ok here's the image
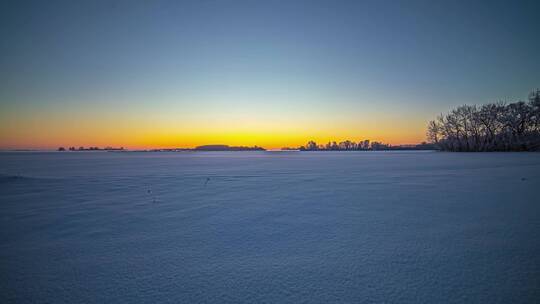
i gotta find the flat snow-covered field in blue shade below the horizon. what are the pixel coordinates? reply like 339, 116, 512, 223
0, 152, 540, 303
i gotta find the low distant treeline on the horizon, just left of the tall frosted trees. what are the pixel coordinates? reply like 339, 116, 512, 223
282, 140, 434, 151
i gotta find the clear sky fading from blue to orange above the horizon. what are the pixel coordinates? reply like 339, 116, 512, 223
0, 0, 540, 149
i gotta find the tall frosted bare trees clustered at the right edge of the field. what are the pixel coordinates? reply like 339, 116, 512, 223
427, 90, 540, 151
